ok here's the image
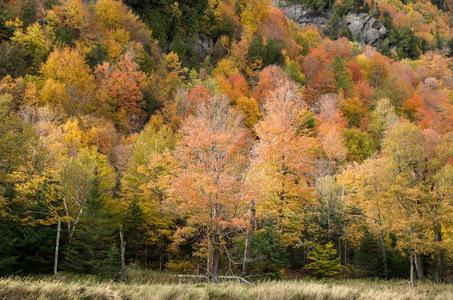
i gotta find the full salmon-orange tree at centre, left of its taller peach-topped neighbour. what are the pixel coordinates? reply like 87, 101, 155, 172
172, 96, 248, 280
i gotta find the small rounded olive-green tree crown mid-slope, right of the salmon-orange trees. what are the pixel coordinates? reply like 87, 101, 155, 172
344, 128, 375, 162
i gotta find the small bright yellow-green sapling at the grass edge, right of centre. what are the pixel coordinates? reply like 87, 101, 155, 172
305, 242, 341, 277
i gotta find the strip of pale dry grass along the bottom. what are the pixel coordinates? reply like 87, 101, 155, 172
0, 277, 453, 300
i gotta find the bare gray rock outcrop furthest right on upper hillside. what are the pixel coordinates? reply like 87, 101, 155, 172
346, 13, 387, 46
